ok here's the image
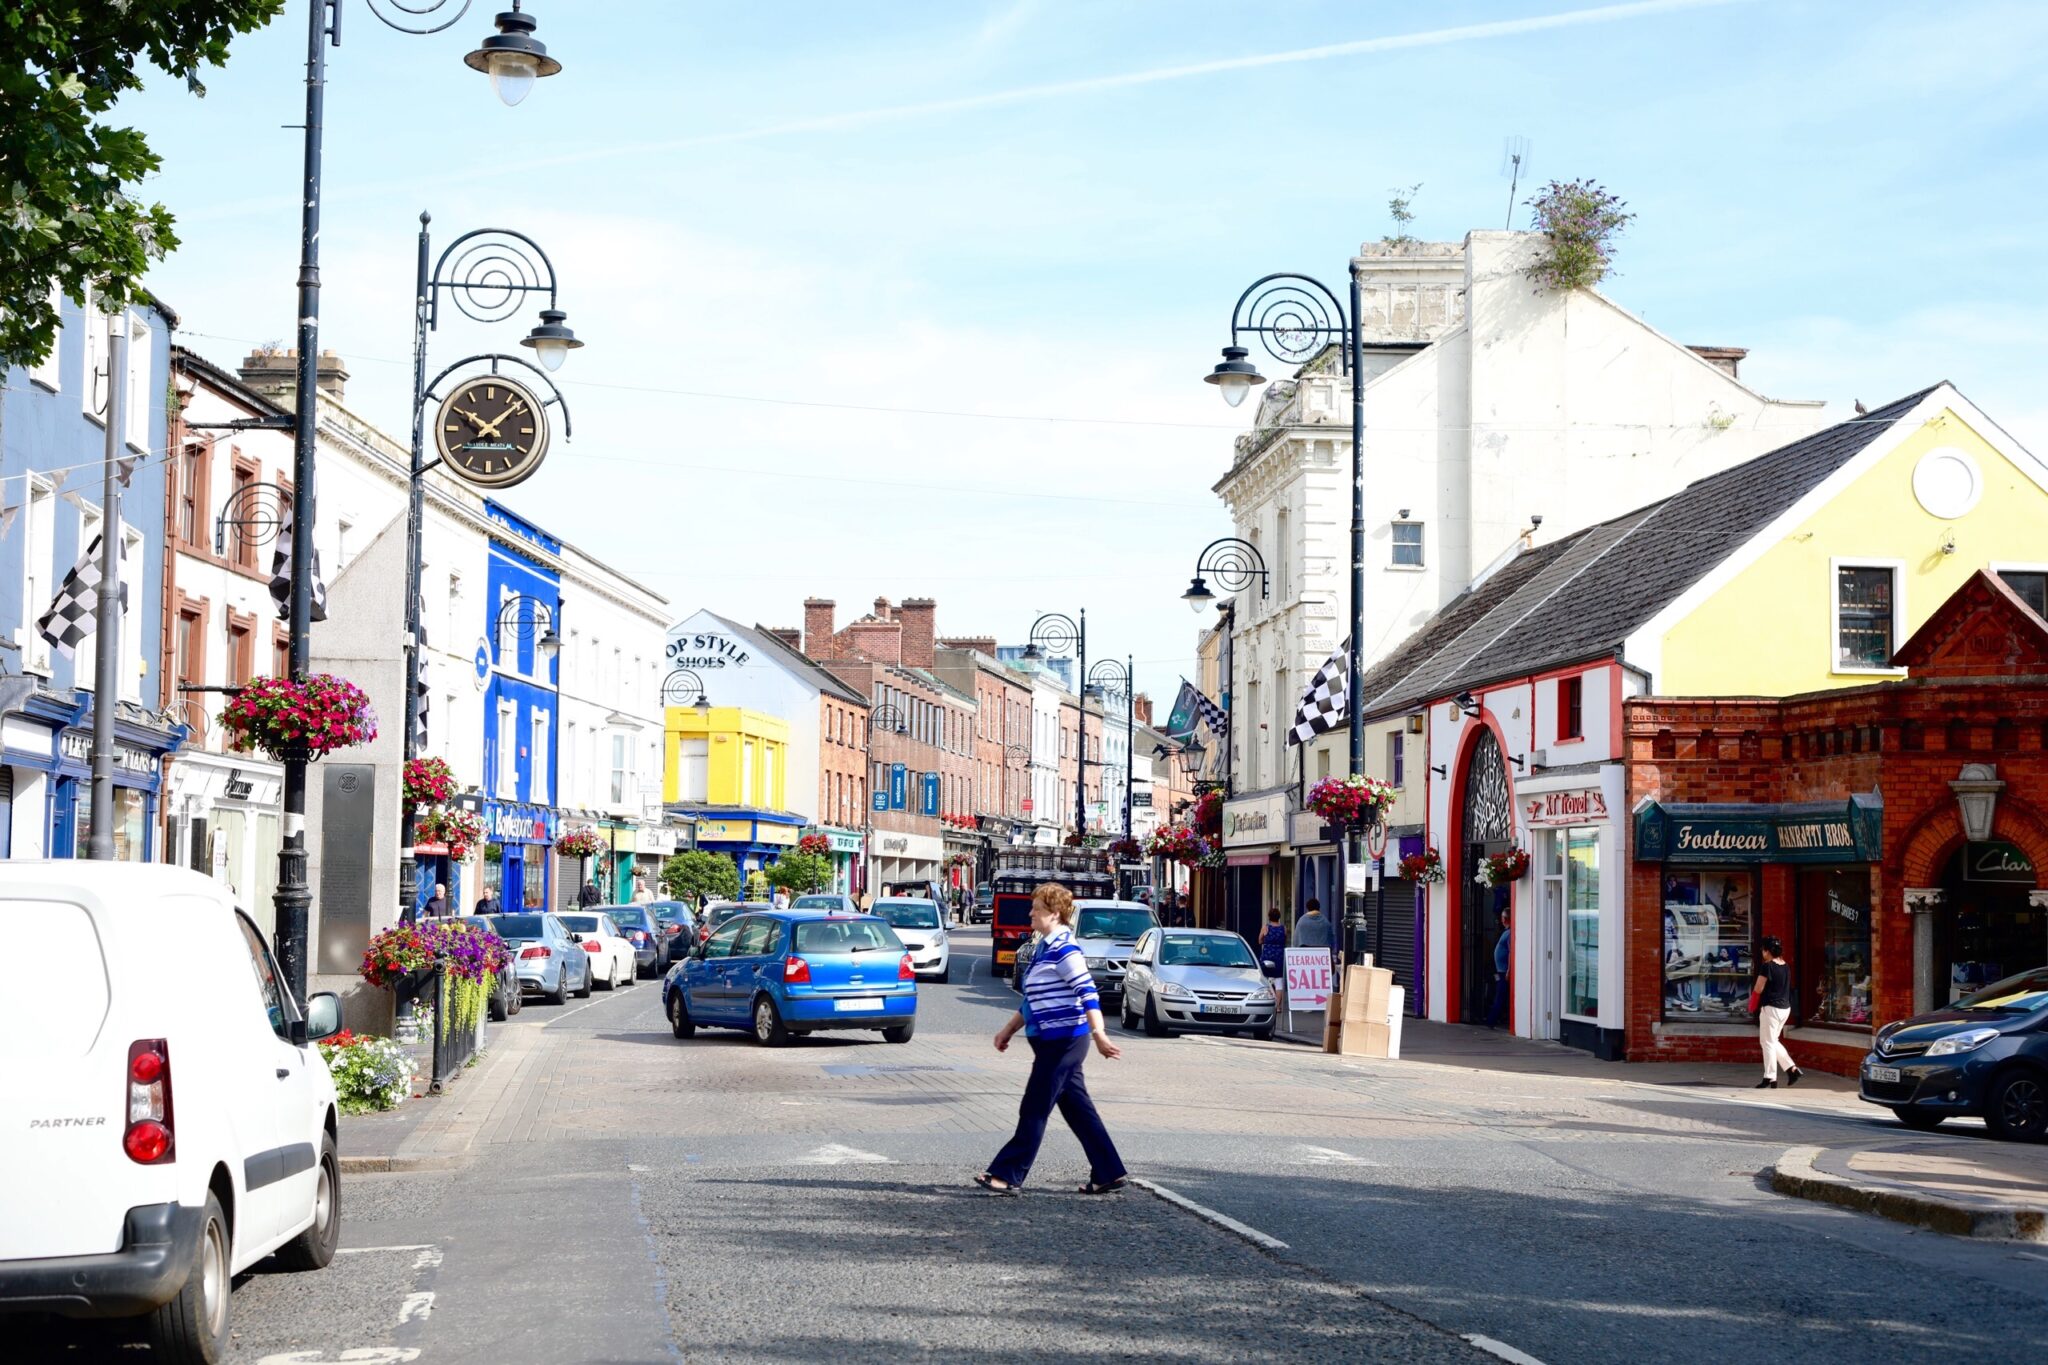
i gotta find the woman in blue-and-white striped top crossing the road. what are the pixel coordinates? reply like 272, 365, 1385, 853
975, 882, 1128, 1195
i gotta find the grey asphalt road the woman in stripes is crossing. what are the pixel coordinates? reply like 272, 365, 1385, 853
10, 931, 2048, 1365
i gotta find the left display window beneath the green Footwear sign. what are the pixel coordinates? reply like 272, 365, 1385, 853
1663, 868, 1757, 1023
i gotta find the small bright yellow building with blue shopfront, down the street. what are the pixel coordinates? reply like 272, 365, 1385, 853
662, 706, 805, 878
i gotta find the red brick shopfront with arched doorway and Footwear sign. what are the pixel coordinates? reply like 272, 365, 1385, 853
1624, 573, 2048, 1074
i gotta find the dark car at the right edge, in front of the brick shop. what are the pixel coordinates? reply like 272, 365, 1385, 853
1862, 966, 2048, 1142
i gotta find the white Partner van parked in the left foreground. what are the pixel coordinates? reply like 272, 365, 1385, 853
0, 860, 342, 1365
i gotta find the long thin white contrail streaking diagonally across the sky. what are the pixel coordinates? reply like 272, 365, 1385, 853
182, 0, 1753, 221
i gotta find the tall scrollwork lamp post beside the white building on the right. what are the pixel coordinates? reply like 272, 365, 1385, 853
1204, 262, 1366, 964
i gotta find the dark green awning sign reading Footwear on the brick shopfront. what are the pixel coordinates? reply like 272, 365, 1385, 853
1636, 792, 1884, 864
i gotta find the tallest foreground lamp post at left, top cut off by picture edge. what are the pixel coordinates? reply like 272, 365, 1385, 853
276, 0, 577, 1001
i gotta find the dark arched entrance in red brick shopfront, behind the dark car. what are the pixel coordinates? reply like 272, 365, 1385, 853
1933, 841, 2048, 1009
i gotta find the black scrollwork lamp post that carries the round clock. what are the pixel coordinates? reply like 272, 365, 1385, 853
397, 218, 582, 933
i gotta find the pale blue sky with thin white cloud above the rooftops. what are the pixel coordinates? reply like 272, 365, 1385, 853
125, 0, 2048, 696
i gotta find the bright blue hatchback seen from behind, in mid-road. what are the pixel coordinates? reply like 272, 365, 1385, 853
662, 909, 918, 1048
